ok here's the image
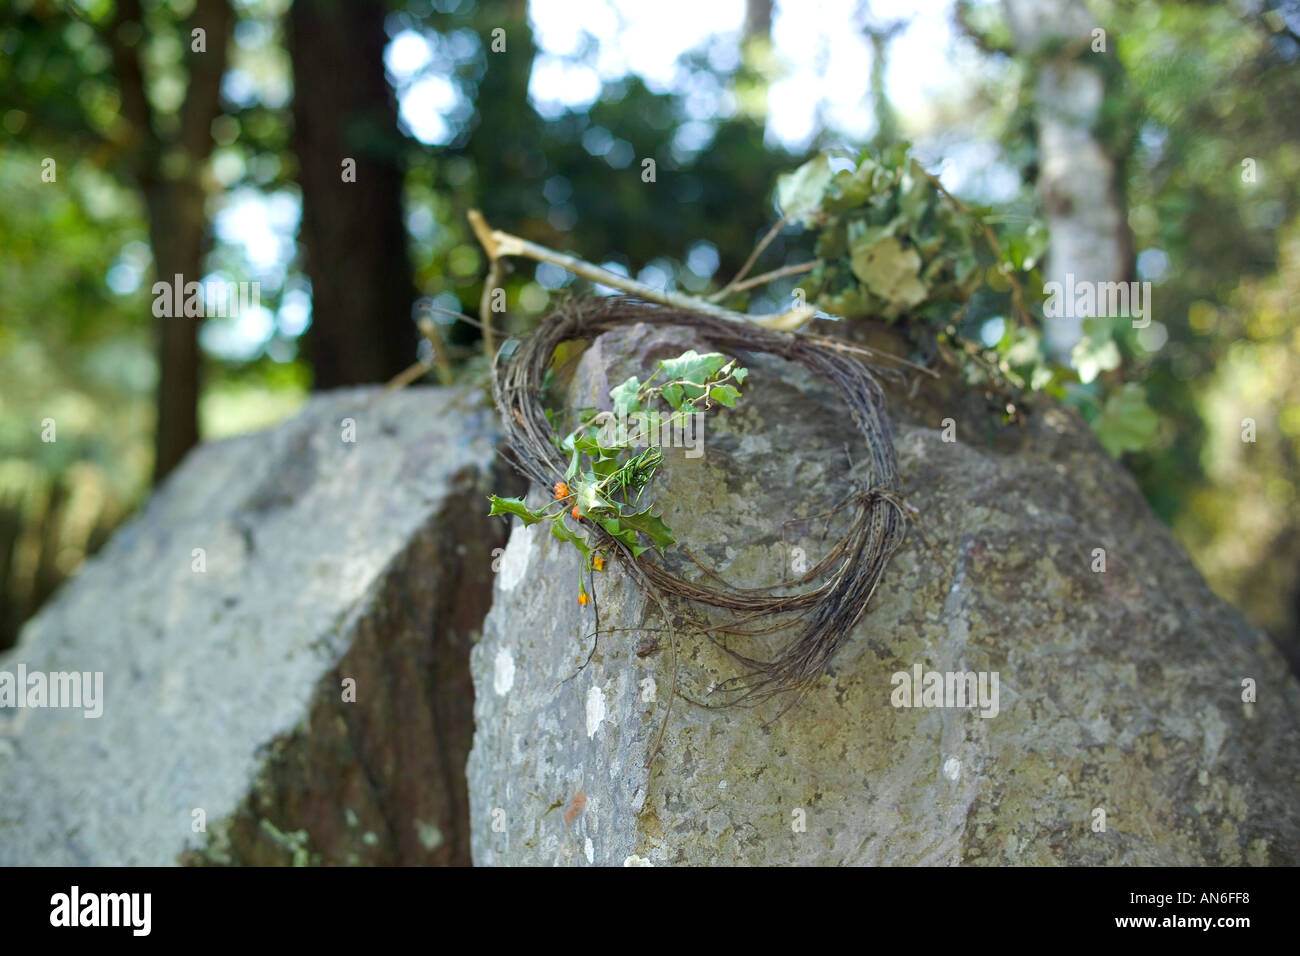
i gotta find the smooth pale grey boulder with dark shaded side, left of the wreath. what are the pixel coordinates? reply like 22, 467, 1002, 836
0, 389, 508, 865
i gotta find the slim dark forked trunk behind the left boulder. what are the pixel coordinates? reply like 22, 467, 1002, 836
104, 0, 234, 483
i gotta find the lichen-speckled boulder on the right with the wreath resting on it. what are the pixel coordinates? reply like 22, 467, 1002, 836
469, 326, 1300, 865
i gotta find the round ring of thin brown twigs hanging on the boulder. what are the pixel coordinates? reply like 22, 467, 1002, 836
493, 297, 906, 712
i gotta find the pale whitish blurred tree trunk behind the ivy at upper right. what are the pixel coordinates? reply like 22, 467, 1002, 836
1004, 0, 1132, 359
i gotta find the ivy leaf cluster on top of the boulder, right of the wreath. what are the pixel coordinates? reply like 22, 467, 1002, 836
776, 144, 1175, 455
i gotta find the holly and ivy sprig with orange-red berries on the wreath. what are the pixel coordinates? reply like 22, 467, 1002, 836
488, 350, 749, 604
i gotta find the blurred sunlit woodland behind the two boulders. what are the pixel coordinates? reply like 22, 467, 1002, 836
0, 0, 1300, 666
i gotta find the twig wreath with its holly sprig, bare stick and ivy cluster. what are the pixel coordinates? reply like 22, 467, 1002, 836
391, 143, 1107, 766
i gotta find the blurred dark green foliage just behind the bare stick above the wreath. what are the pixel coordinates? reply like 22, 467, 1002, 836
390, 0, 801, 345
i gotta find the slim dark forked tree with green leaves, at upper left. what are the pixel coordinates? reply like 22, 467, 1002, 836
16, 0, 234, 481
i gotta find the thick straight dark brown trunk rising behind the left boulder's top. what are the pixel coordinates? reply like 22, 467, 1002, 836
289, 0, 416, 389
